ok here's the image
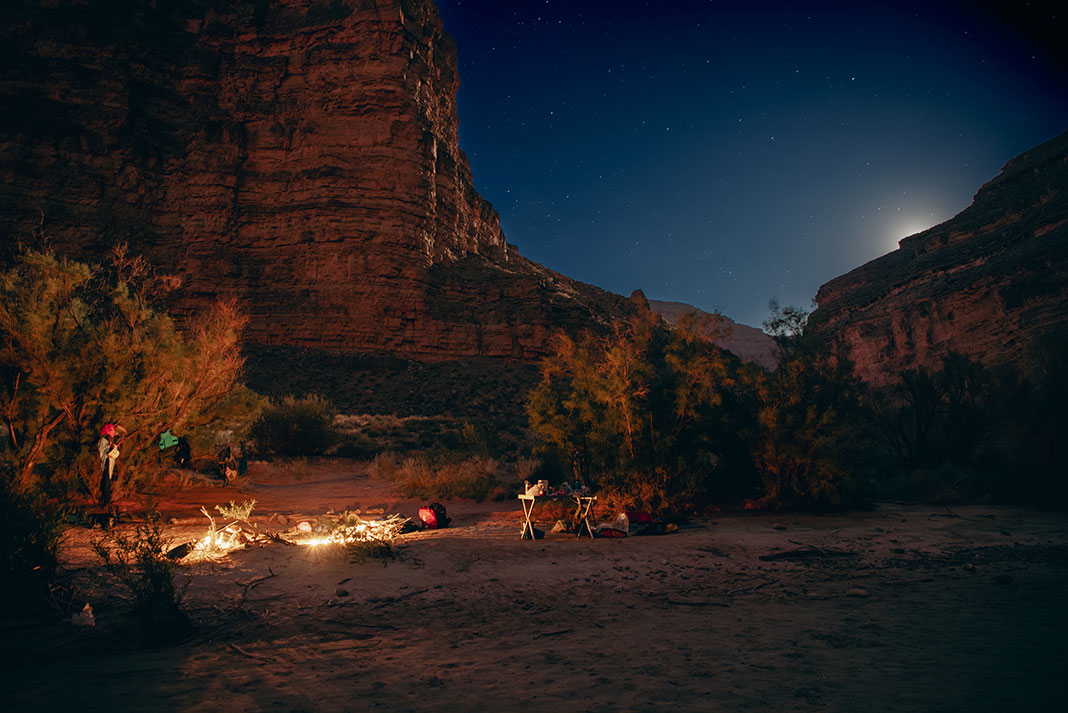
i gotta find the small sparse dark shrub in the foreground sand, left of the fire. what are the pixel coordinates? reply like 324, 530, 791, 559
93, 514, 192, 639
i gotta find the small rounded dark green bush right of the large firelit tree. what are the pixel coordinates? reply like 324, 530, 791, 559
250, 396, 337, 457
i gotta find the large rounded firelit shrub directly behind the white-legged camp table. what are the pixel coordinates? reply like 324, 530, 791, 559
528, 312, 755, 511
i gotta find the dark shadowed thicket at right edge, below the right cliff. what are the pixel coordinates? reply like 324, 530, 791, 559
874, 336, 1068, 508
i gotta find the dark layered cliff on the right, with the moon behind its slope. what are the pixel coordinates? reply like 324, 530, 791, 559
810, 128, 1068, 385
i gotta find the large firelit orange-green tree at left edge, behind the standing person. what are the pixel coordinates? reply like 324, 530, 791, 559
0, 248, 244, 490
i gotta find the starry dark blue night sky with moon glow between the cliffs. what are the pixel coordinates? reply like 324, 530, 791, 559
438, 0, 1068, 326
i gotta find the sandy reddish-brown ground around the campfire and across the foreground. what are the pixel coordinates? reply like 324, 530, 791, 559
0, 463, 1068, 712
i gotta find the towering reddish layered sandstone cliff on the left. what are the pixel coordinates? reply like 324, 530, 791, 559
0, 0, 623, 359
